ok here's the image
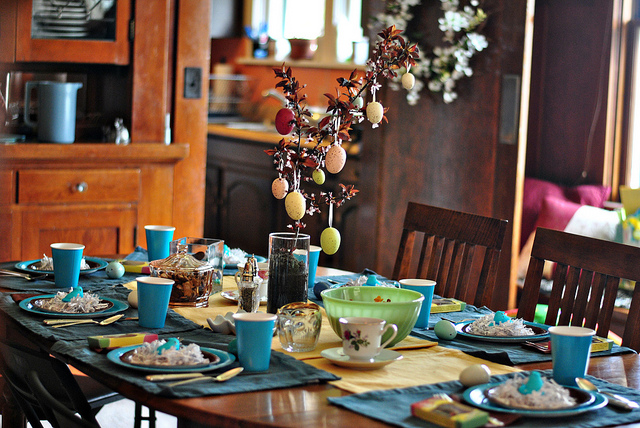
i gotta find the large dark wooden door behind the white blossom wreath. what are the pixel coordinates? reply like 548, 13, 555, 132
356, 0, 526, 307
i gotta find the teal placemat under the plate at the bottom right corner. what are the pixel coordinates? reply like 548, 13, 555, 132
328, 370, 640, 428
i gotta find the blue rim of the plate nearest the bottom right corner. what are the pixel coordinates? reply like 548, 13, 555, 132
462, 383, 609, 418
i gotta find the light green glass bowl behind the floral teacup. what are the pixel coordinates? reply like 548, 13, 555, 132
320, 285, 424, 346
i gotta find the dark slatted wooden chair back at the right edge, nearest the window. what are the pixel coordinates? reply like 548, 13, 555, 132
517, 228, 640, 351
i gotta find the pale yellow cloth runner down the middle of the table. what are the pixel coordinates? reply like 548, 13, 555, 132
125, 276, 520, 393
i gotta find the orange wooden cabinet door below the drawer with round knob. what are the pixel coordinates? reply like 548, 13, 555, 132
20, 204, 137, 260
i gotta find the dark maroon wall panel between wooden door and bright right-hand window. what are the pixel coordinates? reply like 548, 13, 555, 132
526, 0, 616, 185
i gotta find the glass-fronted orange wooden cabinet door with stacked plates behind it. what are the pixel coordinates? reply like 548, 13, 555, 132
15, 0, 131, 65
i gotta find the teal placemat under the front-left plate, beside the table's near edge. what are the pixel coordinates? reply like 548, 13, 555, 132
51, 329, 340, 398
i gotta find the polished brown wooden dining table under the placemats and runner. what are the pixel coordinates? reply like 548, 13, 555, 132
0, 267, 640, 428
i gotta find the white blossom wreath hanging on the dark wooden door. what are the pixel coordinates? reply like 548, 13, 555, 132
372, 0, 489, 105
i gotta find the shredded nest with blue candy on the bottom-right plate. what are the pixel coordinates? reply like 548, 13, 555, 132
487, 371, 577, 410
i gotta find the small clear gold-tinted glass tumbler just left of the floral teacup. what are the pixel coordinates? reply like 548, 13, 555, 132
276, 302, 322, 352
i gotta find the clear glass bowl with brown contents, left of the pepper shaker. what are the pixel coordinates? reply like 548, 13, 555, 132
149, 245, 222, 307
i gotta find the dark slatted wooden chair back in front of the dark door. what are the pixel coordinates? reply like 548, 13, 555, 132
392, 202, 507, 306
